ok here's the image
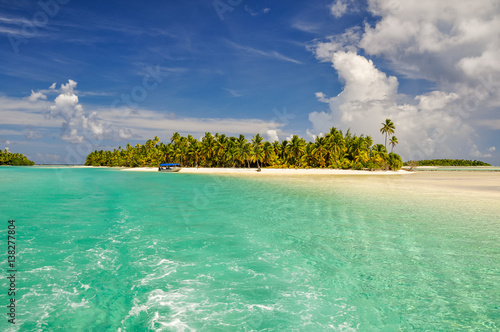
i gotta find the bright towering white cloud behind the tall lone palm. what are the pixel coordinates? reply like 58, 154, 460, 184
309, 51, 486, 159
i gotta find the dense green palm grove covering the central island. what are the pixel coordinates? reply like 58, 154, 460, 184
85, 128, 403, 170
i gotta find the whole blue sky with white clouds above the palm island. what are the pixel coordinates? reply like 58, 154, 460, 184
0, 0, 500, 165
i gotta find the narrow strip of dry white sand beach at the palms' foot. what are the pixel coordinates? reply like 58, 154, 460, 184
122, 167, 413, 175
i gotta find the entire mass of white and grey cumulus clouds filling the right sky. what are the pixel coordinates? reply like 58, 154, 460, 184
309, 0, 500, 159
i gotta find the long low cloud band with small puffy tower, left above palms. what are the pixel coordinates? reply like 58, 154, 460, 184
0, 80, 285, 149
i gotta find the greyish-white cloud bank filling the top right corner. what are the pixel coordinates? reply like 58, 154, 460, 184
359, 0, 500, 84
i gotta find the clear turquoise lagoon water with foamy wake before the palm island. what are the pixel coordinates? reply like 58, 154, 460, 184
0, 167, 500, 331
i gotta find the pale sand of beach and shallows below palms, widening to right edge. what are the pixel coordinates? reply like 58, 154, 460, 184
121, 167, 500, 202
